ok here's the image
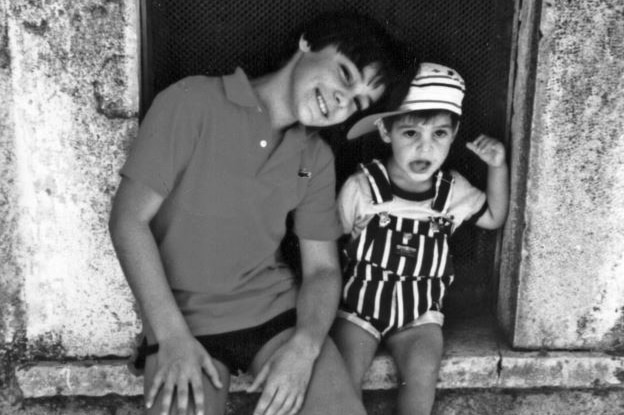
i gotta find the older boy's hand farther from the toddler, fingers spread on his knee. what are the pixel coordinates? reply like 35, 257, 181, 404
145, 336, 223, 415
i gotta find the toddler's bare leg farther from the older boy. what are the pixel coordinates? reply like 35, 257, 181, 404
386, 324, 443, 415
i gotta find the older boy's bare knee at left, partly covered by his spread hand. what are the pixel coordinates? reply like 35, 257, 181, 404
143, 354, 230, 415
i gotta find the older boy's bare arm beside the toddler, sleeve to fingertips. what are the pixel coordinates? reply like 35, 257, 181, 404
248, 239, 342, 415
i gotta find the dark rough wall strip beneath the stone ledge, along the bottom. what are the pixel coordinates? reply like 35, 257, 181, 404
3, 389, 624, 415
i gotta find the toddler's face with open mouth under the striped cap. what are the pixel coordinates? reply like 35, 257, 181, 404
382, 113, 457, 190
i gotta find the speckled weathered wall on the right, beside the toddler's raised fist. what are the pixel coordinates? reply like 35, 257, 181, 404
503, 0, 624, 349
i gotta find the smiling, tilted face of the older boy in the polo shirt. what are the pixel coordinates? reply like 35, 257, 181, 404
290, 38, 385, 127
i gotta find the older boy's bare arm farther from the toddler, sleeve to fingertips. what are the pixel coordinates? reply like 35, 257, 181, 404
109, 177, 221, 414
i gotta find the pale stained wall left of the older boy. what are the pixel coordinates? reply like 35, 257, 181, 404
0, 0, 139, 366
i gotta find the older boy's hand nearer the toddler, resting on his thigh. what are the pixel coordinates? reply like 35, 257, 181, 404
247, 338, 315, 415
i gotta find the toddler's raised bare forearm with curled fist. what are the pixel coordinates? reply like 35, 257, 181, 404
466, 135, 509, 229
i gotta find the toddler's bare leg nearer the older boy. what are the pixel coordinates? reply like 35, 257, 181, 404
331, 318, 379, 398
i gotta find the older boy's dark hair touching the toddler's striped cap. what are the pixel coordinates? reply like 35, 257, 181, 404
299, 13, 414, 107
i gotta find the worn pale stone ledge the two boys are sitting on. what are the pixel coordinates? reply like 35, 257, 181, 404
16, 319, 624, 398
